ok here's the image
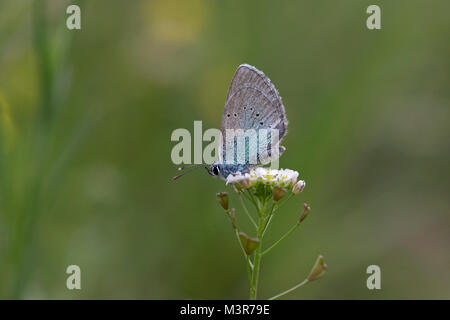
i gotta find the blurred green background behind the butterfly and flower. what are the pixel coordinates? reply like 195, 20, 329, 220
0, 0, 450, 299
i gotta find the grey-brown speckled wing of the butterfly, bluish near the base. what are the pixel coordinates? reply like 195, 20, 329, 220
221, 64, 287, 164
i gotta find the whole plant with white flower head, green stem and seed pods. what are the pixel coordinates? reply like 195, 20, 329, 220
217, 167, 327, 300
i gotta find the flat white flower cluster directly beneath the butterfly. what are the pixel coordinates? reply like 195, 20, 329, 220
227, 167, 305, 193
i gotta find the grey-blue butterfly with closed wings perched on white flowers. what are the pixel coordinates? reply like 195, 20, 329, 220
174, 64, 288, 179
